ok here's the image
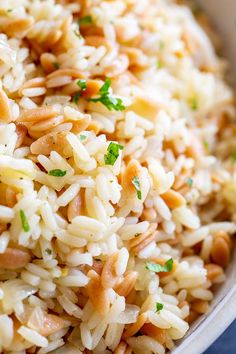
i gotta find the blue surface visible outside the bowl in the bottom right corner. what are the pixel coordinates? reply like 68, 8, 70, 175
204, 321, 236, 354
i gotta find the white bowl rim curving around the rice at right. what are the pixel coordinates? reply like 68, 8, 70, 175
173, 0, 236, 354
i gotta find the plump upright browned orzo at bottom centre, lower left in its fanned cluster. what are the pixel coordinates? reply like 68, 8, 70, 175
86, 270, 110, 315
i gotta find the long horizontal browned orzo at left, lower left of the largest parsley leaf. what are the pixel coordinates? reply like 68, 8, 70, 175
17, 106, 61, 123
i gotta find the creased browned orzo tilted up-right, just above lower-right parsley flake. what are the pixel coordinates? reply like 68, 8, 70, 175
129, 223, 158, 254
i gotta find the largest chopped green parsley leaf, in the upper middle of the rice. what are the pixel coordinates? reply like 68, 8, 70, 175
88, 79, 125, 111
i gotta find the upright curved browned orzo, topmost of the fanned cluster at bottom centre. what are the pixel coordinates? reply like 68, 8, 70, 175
101, 252, 120, 289
